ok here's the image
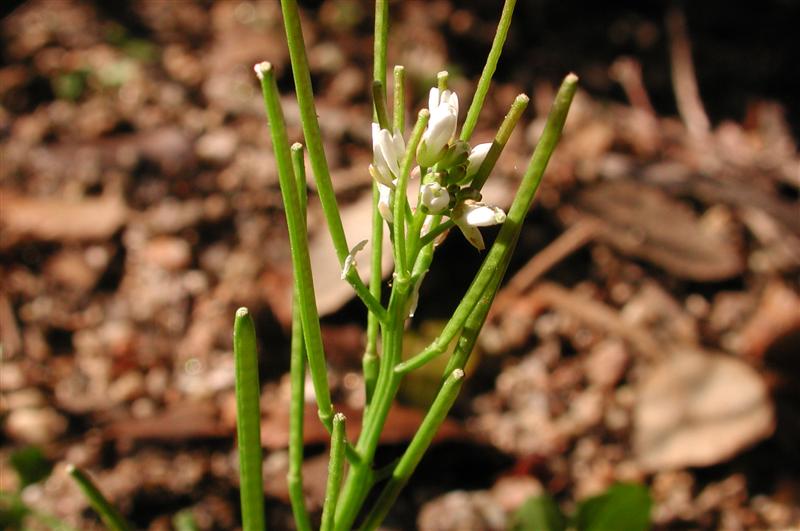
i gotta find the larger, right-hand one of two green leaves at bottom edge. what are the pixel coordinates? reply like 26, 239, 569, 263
575, 483, 653, 531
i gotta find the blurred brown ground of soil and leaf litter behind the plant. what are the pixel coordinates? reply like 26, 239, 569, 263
0, 0, 800, 530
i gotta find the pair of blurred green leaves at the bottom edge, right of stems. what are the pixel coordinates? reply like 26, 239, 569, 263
511, 483, 652, 531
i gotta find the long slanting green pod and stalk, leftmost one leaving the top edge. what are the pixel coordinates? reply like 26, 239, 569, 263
280, 0, 385, 316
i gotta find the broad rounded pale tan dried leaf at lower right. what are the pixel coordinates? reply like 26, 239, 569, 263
633, 348, 774, 470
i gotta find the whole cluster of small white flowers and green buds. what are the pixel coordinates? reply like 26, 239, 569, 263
369, 78, 506, 250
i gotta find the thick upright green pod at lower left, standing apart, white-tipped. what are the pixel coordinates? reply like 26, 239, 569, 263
233, 308, 265, 531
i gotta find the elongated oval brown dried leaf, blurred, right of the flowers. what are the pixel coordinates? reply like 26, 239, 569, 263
574, 181, 744, 281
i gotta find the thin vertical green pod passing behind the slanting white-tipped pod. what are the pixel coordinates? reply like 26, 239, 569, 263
286, 143, 311, 531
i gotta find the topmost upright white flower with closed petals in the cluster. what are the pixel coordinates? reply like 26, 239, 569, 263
417, 87, 458, 168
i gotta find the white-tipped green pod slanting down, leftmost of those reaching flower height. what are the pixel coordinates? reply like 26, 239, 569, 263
256, 63, 333, 429
